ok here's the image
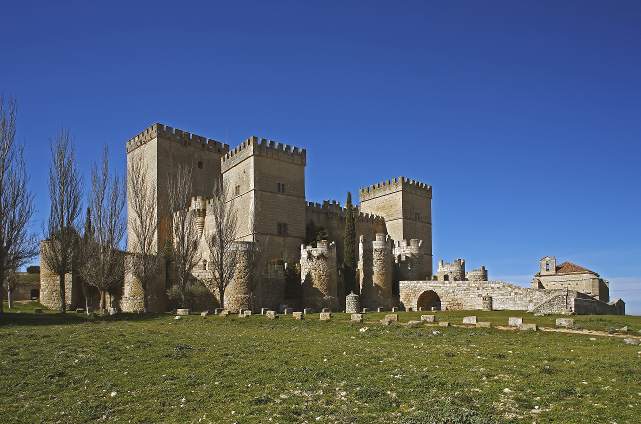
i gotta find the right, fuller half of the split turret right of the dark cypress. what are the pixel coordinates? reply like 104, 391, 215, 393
367, 233, 394, 309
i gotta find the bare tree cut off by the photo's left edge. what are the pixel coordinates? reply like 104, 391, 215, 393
0, 97, 38, 313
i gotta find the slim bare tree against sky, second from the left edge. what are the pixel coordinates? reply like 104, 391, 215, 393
41, 129, 82, 313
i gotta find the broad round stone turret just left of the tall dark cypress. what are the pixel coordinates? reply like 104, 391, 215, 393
300, 240, 338, 310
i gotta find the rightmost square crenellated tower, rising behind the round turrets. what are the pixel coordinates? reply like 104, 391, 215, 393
360, 177, 432, 275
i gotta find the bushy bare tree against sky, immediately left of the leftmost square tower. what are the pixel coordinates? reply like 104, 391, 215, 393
79, 146, 125, 311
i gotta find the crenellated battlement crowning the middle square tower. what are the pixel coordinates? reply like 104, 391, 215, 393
221, 136, 307, 172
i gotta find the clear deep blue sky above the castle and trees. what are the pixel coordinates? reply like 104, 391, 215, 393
0, 0, 641, 314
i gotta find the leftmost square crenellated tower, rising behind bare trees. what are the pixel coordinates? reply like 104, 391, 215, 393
127, 124, 229, 251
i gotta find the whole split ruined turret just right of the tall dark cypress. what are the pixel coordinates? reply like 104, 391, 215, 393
358, 233, 394, 309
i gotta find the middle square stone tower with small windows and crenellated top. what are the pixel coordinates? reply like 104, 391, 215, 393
221, 137, 307, 261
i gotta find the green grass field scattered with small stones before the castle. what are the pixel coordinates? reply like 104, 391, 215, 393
0, 305, 641, 423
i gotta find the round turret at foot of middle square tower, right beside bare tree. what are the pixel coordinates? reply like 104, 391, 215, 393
224, 241, 255, 312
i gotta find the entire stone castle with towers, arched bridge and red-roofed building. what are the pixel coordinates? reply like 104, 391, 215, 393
36, 124, 625, 313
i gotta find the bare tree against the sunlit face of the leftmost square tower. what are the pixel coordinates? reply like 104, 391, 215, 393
127, 156, 161, 312
